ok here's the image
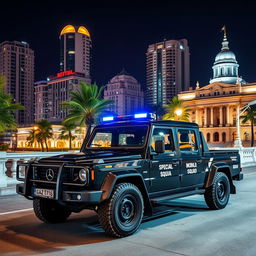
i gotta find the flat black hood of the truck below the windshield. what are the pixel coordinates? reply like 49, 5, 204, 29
38, 151, 141, 164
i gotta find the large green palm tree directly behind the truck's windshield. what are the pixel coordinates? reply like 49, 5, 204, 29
62, 82, 112, 139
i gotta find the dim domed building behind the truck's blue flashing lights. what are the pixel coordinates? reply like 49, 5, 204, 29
104, 69, 144, 115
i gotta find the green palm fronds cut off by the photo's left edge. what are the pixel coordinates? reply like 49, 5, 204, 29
0, 76, 24, 134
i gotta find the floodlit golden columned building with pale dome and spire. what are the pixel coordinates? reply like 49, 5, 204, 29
178, 27, 256, 147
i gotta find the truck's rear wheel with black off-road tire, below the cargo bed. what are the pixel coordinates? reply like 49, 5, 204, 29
204, 172, 230, 210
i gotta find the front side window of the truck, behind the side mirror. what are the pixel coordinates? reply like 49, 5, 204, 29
150, 128, 175, 152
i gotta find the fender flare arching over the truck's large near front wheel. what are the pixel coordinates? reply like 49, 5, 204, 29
101, 170, 153, 216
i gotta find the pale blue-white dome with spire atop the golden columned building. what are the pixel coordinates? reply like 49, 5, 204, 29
210, 28, 245, 84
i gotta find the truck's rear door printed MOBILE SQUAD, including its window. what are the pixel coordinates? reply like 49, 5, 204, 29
176, 128, 206, 187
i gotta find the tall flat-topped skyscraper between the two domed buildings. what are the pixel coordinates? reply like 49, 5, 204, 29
145, 39, 190, 107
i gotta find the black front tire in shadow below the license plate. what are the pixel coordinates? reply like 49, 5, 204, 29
33, 198, 71, 223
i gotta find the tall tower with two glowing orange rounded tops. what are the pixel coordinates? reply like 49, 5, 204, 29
60, 25, 92, 78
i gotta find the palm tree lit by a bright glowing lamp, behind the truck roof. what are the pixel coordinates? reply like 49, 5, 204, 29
163, 96, 190, 121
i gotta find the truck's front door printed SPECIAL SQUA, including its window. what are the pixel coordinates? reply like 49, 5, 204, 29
149, 127, 181, 192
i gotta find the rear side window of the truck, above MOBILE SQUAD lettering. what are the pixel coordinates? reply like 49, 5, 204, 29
178, 129, 198, 152
